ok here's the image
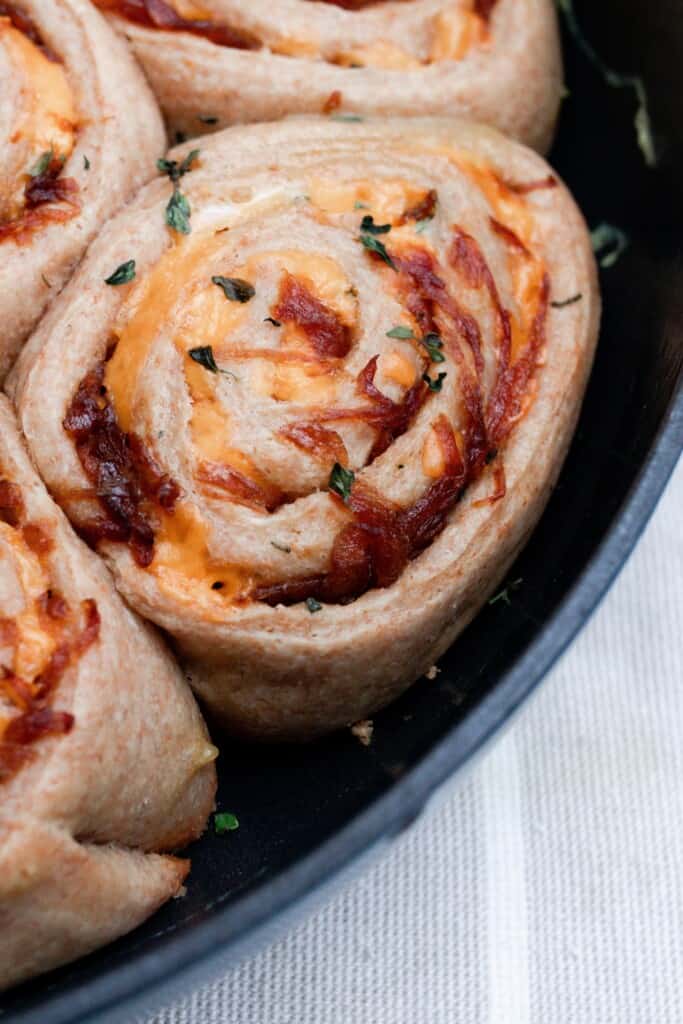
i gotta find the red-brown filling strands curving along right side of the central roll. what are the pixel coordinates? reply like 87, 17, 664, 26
252, 224, 550, 604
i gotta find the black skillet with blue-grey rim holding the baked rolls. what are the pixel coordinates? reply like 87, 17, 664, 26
0, 0, 683, 1024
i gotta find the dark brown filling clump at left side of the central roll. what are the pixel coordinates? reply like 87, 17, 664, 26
63, 364, 180, 567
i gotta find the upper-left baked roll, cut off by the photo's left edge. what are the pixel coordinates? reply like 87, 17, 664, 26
0, 0, 165, 382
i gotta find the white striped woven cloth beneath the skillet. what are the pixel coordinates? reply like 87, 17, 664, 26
144, 463, 683, 1024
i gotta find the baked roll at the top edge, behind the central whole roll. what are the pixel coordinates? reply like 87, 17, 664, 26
96, 0, 561, 152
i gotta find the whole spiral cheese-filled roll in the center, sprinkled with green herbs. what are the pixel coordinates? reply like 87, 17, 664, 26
10, 119, 599, 738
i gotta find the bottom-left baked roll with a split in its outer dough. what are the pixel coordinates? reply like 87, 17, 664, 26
0, 396, 217, 988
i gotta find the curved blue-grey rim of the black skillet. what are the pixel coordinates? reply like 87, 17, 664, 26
6, 362, 683, 1024
